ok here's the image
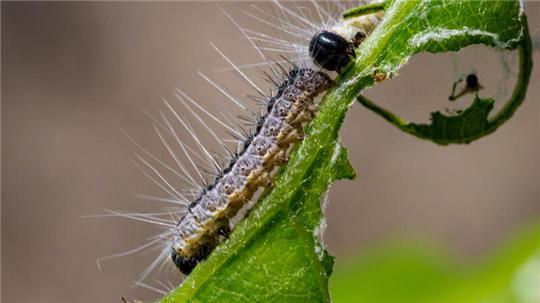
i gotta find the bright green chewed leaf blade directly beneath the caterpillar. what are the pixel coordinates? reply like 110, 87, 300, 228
162, 0, 532, 302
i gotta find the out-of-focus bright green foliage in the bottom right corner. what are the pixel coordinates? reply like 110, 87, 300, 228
330, 223, 540, 303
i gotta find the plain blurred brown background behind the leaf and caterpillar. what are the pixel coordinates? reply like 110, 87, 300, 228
2, 2, 540, 303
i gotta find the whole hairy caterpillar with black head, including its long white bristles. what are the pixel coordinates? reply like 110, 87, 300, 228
98, 2, 380, 285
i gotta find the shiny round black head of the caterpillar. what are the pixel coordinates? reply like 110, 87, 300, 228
309, 31, 355, 72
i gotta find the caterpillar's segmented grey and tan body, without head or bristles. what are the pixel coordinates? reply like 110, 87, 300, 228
171, 68, 333, 274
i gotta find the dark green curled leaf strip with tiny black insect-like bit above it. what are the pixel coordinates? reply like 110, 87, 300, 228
358, 17, 532, 145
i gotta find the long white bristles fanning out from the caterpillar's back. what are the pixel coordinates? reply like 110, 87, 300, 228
96, 0, 380, 294
